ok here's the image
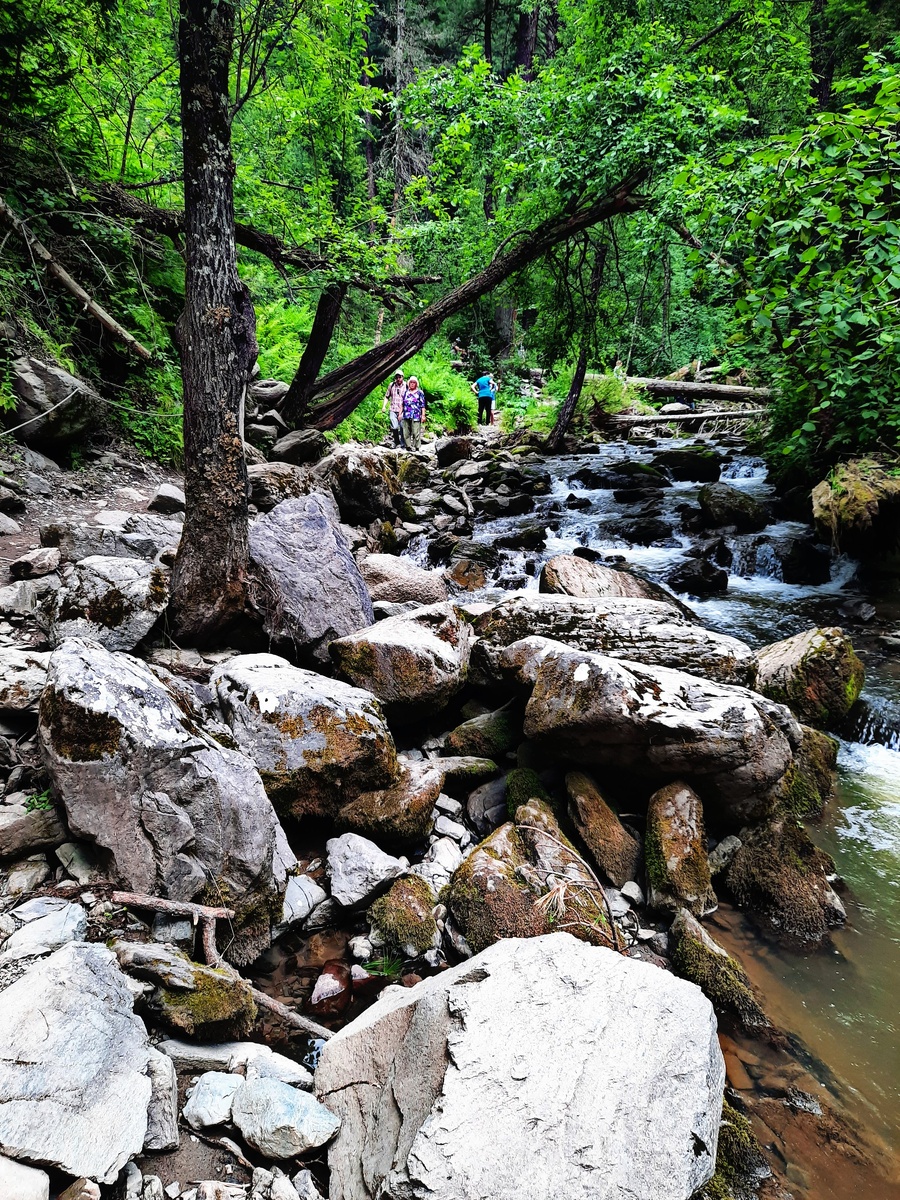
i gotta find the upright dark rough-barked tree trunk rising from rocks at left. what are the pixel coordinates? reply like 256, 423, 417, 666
170, 0, 257, 644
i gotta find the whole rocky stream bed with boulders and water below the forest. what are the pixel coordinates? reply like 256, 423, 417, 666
0, 414, 900, 1200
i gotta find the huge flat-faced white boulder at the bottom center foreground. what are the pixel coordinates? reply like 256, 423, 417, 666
316, 934, 725, 1200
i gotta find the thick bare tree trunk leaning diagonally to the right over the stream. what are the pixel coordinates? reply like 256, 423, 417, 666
307, 169, 648, 430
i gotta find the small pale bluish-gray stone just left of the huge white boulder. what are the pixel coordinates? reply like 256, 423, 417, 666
232, 1079, 341, 1159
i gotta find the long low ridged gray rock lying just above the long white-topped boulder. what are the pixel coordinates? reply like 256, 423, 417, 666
475, 592, 756, 686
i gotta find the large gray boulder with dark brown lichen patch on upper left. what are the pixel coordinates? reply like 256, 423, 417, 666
38, 638, 283, 961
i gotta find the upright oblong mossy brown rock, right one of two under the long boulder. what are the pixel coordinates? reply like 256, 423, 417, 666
644, 782, 719, 917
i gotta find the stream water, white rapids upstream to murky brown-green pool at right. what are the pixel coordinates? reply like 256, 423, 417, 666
460, 440, 900, 1200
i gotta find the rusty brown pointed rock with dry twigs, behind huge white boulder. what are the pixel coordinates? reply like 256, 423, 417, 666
448, 799, 612, 953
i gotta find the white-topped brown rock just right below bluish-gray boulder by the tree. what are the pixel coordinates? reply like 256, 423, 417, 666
330, 604, 473, 715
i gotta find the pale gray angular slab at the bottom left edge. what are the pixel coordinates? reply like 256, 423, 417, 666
0, 942, 150, 1183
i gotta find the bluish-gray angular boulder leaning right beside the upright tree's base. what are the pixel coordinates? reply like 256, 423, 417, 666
250, 493, 374, 662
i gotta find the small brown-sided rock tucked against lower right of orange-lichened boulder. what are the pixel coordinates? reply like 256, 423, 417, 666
336, 760, 444, 848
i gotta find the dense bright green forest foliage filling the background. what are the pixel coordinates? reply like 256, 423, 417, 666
0, 0, 900, 463
